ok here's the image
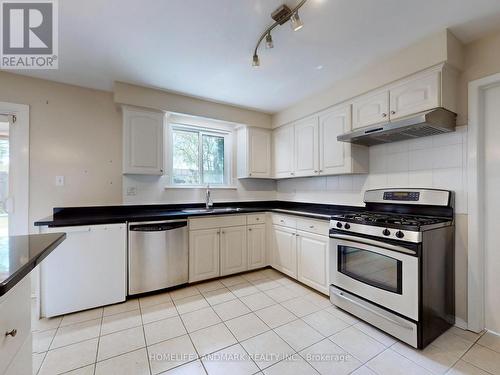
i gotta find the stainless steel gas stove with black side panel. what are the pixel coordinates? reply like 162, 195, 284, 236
330, 189, 455, 348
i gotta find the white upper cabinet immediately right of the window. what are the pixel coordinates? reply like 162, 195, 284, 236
237, 127, 272, 178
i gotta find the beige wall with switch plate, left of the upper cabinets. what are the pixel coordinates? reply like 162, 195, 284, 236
0, 72, 122, 227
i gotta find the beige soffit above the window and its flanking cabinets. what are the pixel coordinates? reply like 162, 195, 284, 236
113, 82, 271, 128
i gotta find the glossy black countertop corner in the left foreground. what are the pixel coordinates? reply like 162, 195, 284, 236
0, 233, 66, 297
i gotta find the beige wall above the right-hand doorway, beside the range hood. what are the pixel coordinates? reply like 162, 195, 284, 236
458, 31, 500, 124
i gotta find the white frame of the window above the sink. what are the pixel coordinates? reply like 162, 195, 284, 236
167, 122, 233, 189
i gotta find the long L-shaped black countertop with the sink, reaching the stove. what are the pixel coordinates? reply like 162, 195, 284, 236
34, 201, 363, 227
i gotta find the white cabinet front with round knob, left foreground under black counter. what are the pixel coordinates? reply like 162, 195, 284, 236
0, 277, 31, 374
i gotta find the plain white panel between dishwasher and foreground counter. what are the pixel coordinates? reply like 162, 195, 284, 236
40, 224, 127, 317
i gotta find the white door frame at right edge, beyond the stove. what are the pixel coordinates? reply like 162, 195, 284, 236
467, 73, 500, 332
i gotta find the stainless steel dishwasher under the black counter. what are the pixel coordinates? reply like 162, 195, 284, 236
128, 220, 188, 295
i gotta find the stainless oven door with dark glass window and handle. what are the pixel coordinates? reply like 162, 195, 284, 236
330, 233, 419, 321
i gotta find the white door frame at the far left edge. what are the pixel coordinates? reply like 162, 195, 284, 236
0, 102, 30, 235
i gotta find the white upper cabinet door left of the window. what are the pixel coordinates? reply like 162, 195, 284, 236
123, 108, 164, 175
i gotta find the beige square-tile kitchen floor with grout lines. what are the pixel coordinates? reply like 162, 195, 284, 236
33, 269, 500, 375
